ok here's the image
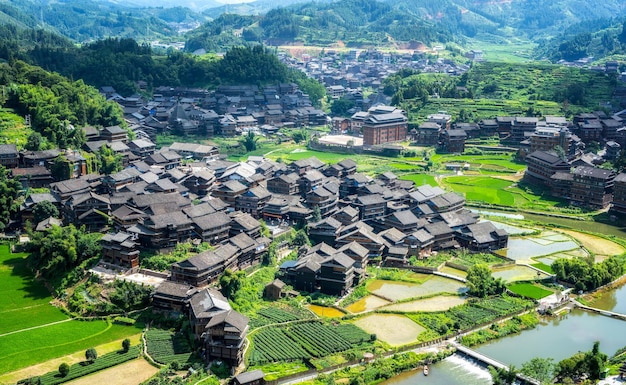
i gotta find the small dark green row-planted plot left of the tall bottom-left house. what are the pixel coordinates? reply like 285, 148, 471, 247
146, 329, 195, 365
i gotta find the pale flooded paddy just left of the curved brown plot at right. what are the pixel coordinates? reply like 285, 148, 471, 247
497, 231, 580, 261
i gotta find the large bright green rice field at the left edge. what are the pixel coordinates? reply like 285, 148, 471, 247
0, 245, 140, 373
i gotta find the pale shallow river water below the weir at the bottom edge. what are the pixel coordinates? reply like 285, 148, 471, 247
382, 354, 491, 385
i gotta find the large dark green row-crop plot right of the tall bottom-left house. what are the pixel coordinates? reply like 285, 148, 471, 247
249, 321, 370, 365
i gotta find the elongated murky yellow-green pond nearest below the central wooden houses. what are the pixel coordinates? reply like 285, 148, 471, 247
367, 276, 467, 301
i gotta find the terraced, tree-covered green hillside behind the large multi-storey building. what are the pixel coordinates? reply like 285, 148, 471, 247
384, 62, 616, 123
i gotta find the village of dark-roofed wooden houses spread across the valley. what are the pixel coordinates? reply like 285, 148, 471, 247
0, 48, 626, 384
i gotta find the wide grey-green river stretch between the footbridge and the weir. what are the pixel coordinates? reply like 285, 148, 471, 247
473, 310, 626, 367
